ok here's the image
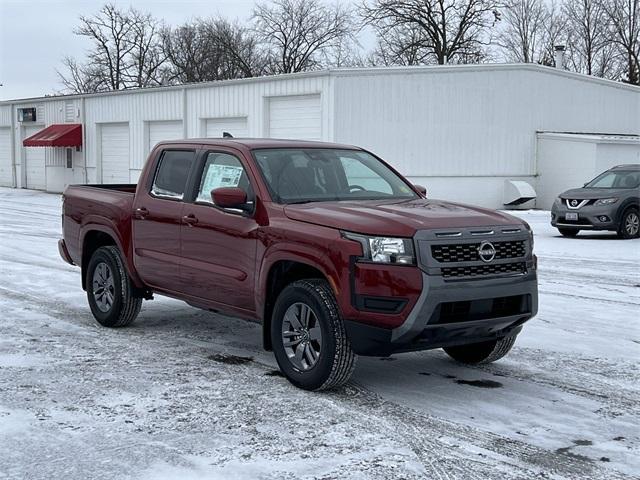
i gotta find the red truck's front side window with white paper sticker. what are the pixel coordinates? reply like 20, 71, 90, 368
196, 152, 253, 204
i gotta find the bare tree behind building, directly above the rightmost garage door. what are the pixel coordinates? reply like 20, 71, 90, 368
253, 0, 355, 73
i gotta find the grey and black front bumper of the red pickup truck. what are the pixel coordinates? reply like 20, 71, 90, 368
345, 270, 538, 356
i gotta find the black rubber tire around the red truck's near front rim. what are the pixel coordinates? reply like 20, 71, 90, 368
271, 279, 356, 391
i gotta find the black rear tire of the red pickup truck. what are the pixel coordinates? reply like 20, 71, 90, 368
86, 246, 142, 328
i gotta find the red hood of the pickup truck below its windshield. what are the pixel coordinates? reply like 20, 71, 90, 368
284, 199, 523, 237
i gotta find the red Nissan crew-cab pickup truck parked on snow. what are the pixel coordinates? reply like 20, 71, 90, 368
59, 139, 538, 390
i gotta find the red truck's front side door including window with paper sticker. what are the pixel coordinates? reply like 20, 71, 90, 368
180, 148, 258, 313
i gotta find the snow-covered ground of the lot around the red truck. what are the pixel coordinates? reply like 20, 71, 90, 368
0, 189, 640, 480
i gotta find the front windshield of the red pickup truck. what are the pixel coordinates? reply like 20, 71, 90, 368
253, 148, 417, 203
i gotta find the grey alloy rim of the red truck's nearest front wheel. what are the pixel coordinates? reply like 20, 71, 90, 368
282, 302, 322, 371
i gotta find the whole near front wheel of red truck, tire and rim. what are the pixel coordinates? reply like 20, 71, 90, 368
271, 279, 356, 390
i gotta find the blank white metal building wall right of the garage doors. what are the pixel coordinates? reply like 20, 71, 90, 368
334, 65, 640, 208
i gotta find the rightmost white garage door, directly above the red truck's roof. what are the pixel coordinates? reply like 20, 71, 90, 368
268, 95, 322, 140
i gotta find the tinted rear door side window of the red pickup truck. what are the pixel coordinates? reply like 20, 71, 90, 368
151, 150, 195, 200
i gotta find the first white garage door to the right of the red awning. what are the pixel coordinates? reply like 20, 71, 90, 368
100, 123, 129, 183
